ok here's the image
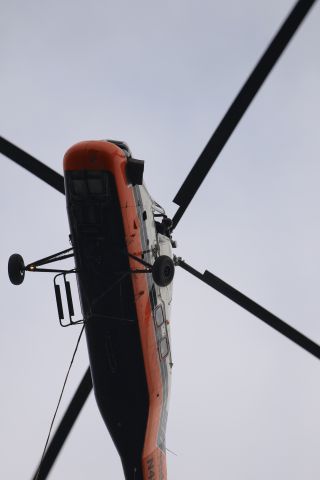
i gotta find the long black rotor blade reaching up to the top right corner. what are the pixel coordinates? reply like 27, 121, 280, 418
173, 0, 316, 228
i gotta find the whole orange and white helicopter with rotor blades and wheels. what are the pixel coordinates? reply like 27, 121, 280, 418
0, 0, 320, 480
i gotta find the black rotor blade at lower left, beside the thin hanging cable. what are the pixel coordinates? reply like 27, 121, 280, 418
32, 367, 92, 480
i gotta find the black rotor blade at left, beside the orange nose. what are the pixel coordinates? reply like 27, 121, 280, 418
0, 137, 64, 194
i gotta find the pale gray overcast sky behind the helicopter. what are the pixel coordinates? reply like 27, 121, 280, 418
0, 0, 320, 480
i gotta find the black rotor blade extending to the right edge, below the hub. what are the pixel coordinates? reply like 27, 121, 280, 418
177, 259, 320, 359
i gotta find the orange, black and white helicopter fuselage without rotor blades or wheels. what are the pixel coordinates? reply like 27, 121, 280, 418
64, 141, 172, 480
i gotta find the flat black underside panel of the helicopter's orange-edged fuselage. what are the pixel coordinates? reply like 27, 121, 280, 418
65, 171, 148, 480
